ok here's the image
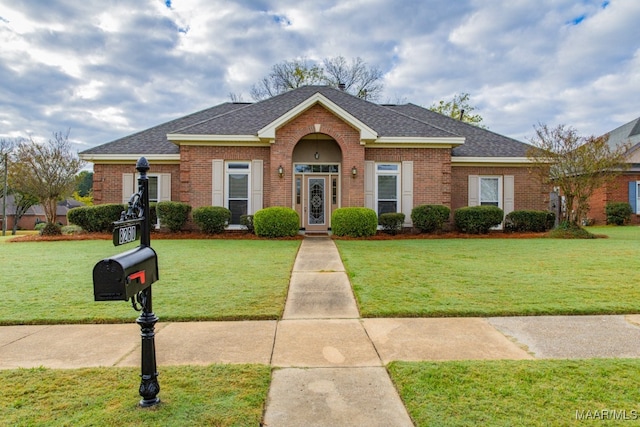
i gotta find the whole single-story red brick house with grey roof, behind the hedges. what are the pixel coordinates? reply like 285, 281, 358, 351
80, 86, 547, 232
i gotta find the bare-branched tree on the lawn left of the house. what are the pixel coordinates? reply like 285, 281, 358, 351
10, 131, 84, 231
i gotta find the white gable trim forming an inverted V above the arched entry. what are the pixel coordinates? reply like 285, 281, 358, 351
258, 93, 378, 141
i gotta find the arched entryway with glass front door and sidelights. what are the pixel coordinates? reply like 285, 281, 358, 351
292, 133, 342, 233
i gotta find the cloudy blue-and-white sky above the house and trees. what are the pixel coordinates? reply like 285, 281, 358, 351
0, 0, 640, 154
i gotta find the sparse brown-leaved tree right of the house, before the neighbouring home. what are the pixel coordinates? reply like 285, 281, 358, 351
527, 124, 630, 226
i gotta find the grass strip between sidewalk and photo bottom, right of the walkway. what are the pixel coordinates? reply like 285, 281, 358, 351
388, 359, 640, 427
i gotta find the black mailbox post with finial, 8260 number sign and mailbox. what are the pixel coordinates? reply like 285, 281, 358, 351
93, 157, 160, 407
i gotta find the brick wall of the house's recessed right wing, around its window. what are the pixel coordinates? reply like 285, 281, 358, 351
451, 165, 549, 211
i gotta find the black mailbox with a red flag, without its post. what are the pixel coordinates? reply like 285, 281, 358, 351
93, 246, 158, 301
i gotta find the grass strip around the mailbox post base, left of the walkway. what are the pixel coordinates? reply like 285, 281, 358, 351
0, 365, 270, 427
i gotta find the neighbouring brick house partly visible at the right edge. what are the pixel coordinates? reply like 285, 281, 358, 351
587, 117, 640, 224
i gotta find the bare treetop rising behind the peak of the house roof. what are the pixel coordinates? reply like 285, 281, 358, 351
248, 56, 383, 101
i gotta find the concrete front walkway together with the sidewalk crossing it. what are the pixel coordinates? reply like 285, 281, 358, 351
0, 237, 640, 426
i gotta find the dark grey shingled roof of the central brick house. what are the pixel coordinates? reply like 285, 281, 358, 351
81, 86, 528, 157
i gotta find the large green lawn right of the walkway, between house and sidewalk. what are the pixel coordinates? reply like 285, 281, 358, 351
336, 227, 640, 317
